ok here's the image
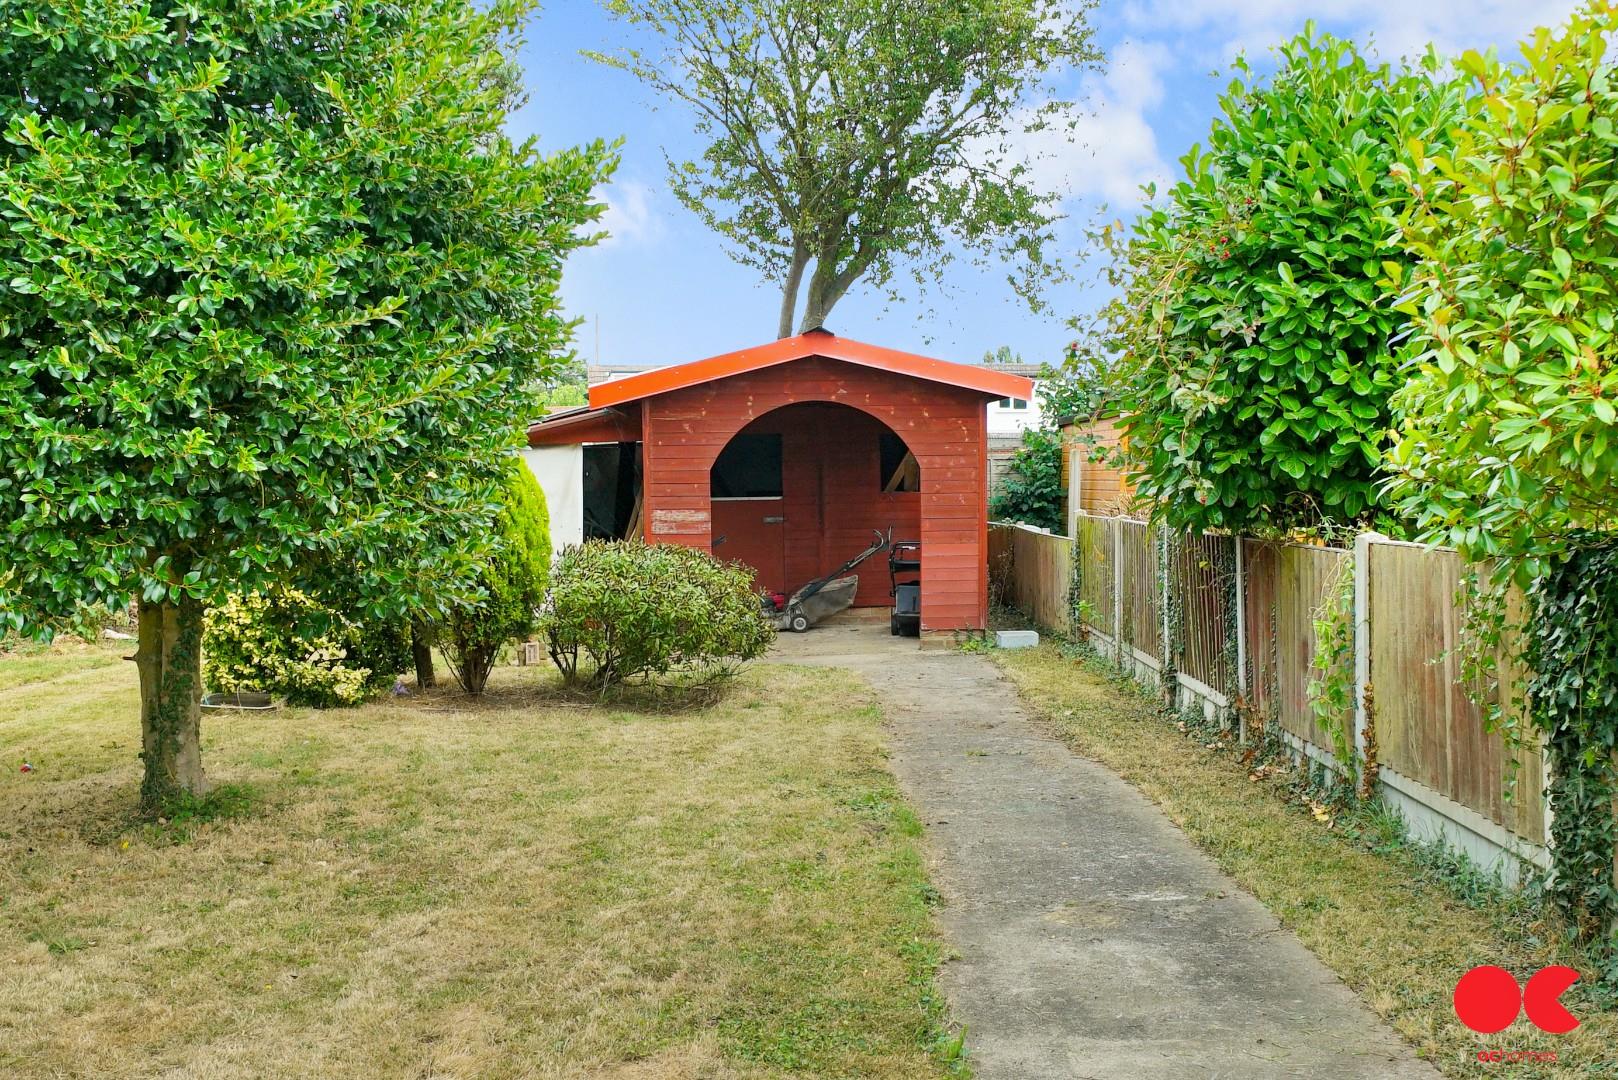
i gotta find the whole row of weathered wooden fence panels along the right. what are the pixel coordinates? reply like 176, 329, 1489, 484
989, 515, 1559, 874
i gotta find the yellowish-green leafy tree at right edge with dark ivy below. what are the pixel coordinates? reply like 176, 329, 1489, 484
1388, 2, 1618, 945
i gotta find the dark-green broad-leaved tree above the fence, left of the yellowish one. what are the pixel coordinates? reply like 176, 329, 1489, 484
1103, 26, 1463, 529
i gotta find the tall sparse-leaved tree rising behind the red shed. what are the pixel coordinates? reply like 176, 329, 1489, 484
592, 0, 1100, 337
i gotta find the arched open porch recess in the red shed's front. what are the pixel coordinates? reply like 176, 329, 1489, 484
709, 402, 921, 607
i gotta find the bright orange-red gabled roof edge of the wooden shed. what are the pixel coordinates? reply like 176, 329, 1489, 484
591, 330, 1034, 410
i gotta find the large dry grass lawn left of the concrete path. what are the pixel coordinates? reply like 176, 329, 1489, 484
0, 646, 943, 1078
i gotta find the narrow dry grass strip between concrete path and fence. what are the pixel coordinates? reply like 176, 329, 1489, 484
995, 644, 1618, 1077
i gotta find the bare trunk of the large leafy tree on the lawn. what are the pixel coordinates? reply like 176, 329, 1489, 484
134, 601, 207, 810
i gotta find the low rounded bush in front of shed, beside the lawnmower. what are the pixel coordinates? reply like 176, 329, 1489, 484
540, 541, 775, 690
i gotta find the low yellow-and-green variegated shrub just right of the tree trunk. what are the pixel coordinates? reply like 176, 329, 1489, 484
202, 588, 409, 709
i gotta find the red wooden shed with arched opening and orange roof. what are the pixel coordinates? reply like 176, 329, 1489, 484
527, 330, 1032, 631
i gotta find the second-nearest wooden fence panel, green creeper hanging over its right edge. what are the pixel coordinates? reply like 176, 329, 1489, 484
1243, 541, 1354, 750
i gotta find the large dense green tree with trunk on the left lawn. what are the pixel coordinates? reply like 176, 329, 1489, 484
0, 0, 612, 806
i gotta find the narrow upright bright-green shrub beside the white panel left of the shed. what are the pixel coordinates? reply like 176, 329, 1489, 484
438, 465, 550, 693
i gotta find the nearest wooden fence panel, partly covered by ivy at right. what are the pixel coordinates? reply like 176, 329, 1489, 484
1369, 542, 1545, 842
